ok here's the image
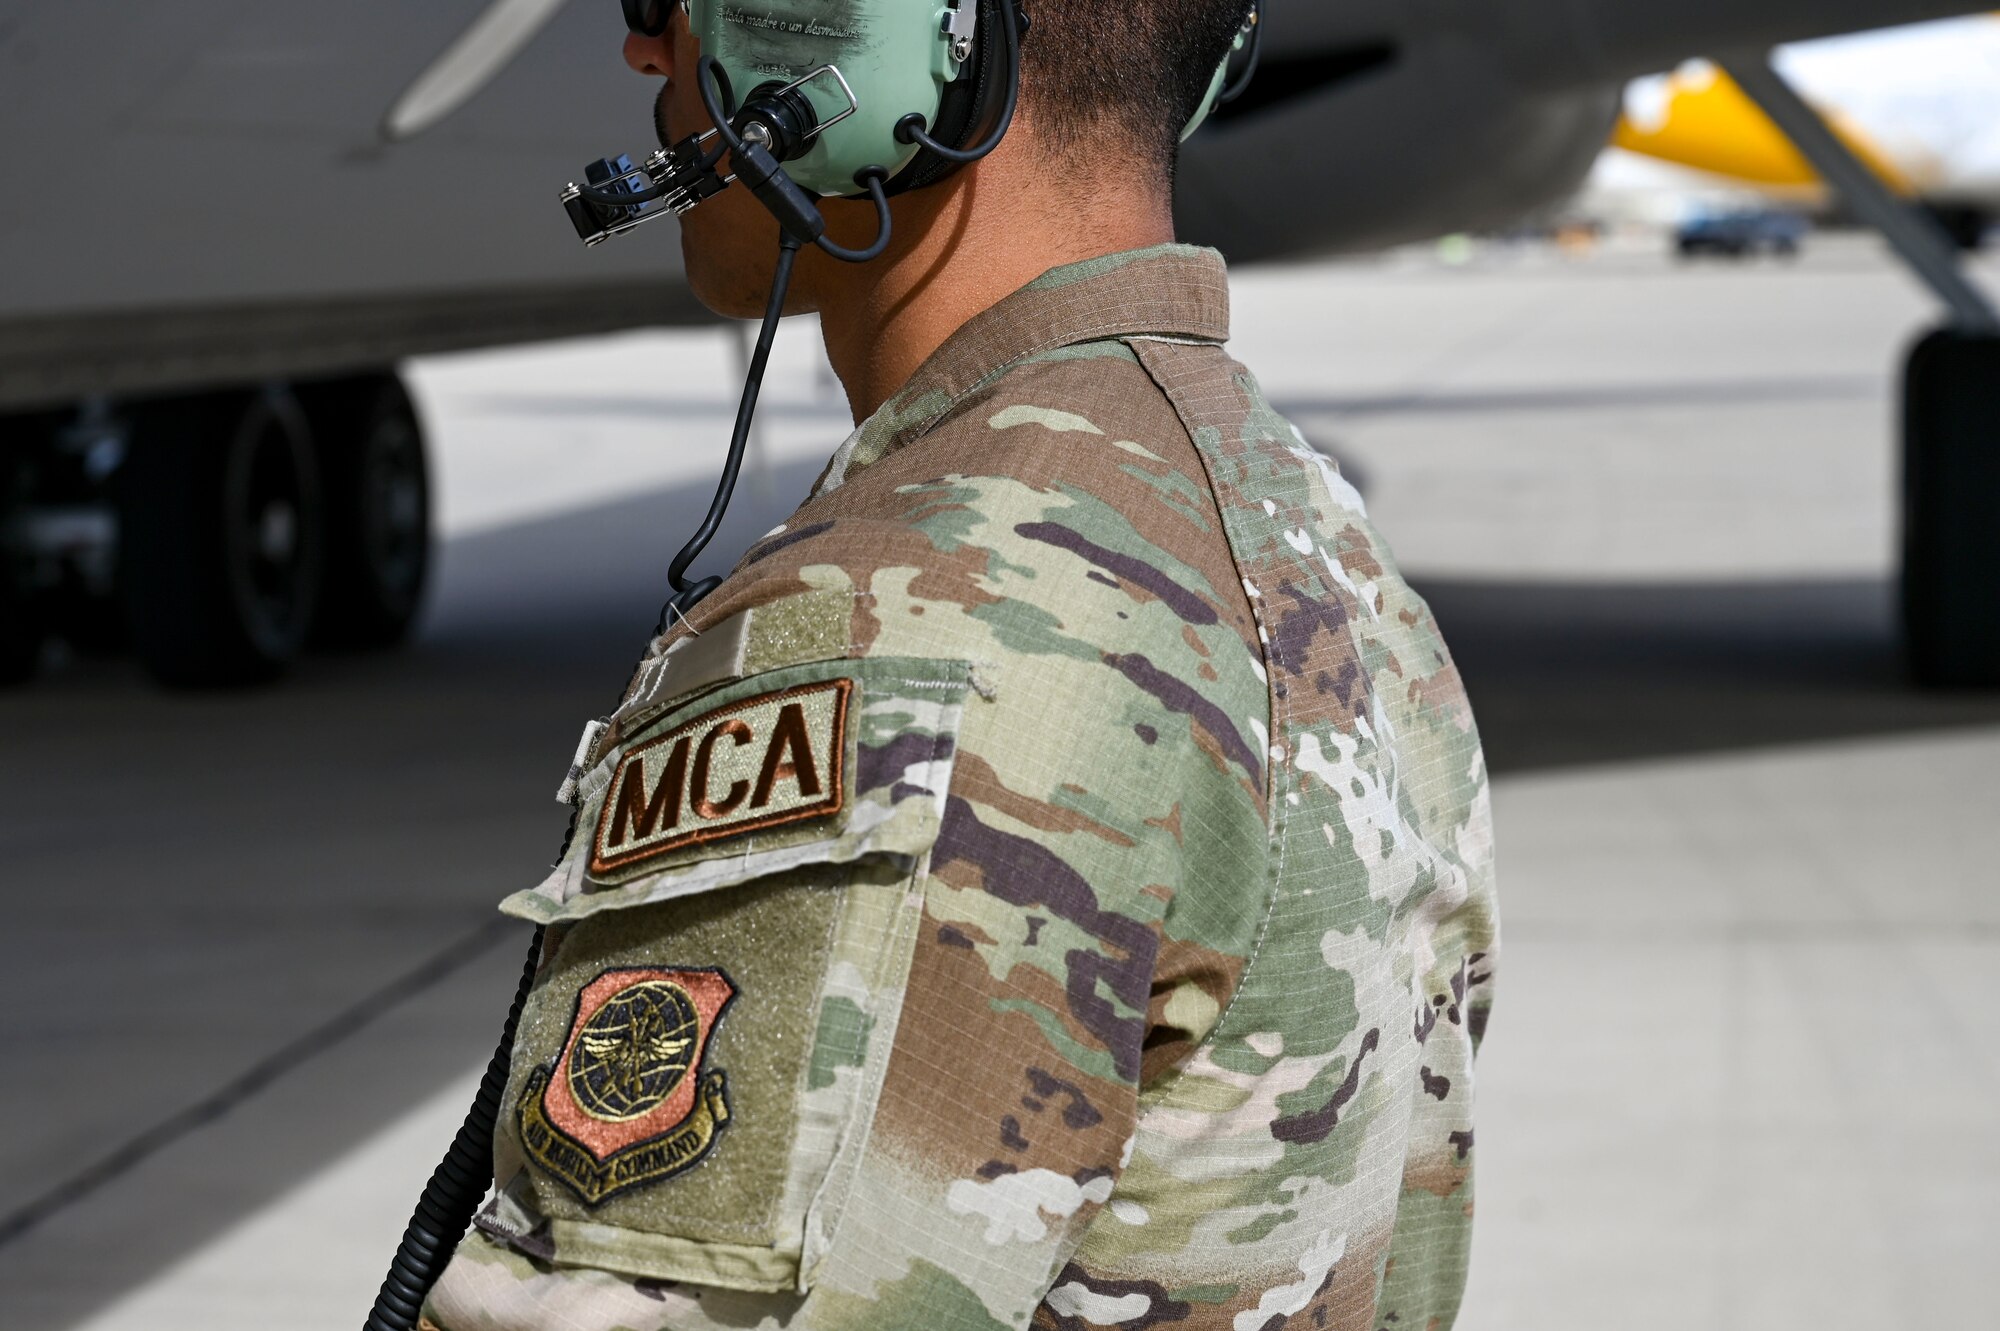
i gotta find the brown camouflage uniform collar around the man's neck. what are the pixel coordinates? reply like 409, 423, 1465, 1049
814, 246, 1230, 494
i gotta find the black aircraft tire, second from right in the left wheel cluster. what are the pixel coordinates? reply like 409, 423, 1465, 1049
118, 388, 326, 687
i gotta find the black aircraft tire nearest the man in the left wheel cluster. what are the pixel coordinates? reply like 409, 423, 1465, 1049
298, 372, 430, 650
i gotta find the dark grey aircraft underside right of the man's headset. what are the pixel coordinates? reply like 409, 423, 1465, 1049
1180, 0, 1984, 260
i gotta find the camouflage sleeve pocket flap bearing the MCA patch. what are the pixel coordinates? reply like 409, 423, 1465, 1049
500, 658, 972, 923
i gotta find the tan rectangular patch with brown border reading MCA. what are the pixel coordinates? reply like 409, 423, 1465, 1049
590, 679, 854, 875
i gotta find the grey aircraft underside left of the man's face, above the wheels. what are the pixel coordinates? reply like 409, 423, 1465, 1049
0, 0, 708, 406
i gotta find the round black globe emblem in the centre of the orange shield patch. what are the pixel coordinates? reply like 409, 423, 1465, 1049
570, 979, 702, 1123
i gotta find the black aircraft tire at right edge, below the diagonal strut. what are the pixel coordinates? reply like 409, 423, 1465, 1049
1902, 328, 2000, 687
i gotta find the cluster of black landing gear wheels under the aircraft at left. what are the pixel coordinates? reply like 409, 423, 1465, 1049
0, 370, 430, 687
